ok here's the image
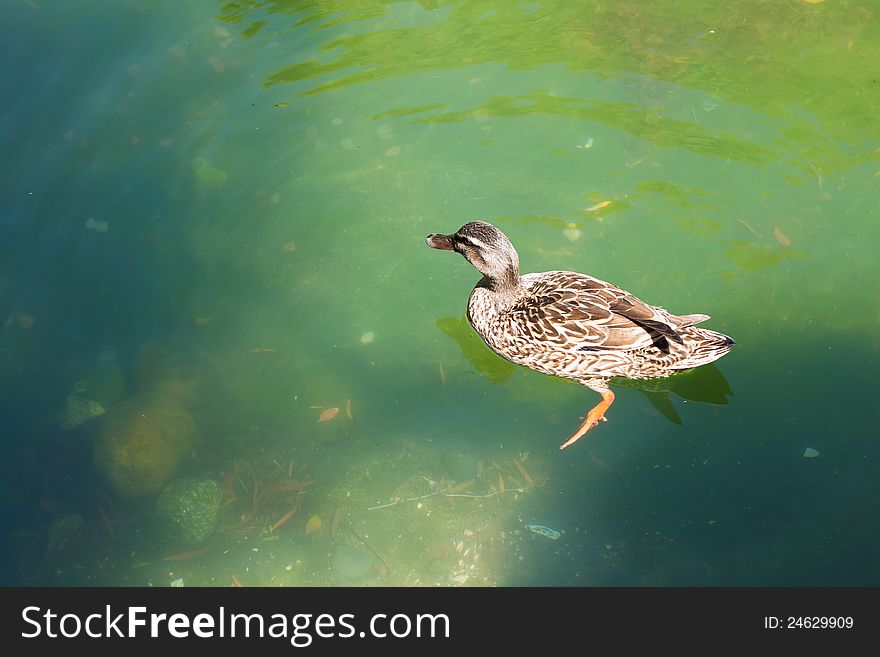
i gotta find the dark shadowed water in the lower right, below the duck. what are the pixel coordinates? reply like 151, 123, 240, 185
502, 335, 880, 586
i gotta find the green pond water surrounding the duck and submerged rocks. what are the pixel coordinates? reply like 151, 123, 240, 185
0, 0, 880, 586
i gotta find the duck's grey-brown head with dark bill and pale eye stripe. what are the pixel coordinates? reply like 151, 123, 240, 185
425, 221, 519, 283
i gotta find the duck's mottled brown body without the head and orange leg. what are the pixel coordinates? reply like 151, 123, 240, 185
468, 271, 733, 384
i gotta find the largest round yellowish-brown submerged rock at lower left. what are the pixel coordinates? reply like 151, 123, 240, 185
94, 393, 198, 498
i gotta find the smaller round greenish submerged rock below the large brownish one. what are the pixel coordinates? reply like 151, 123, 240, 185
156, 478, 223, 545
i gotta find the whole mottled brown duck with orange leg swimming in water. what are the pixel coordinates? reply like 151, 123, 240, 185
425, 220, 735, 449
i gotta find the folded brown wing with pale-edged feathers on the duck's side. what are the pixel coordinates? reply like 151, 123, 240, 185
511, 271, 688, 351
